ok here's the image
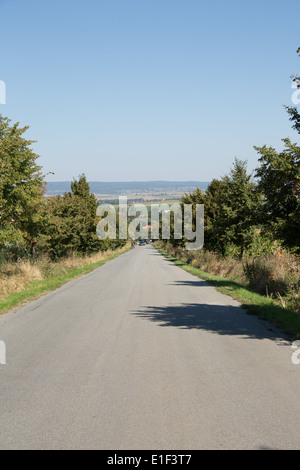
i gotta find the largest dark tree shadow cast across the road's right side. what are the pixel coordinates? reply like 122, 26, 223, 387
132, 303, 284, 339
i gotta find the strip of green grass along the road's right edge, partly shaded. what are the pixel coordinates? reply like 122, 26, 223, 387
156, 246, 300, 340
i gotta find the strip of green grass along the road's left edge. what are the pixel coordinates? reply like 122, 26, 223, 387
0, 248, 130, 315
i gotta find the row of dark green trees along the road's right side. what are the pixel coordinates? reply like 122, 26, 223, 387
177, 147, 300, 258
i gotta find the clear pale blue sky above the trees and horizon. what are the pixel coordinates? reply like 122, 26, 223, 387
0, 0, 300, 181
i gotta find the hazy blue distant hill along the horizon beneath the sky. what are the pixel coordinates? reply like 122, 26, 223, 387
46, 181, 209, 196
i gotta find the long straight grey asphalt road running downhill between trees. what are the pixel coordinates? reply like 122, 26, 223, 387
0, 246, 300, 450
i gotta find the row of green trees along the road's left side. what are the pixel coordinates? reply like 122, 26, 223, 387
0, 115, 124, 259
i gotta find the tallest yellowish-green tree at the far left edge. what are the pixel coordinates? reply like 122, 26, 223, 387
0, 115, 44, 250
